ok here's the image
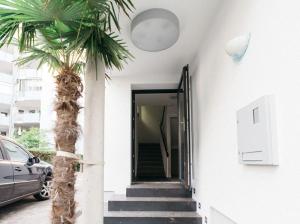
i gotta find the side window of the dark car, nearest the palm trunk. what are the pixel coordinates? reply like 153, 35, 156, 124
2, 140, 29, 162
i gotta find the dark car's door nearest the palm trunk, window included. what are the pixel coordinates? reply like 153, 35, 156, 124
2, 140, 42, 198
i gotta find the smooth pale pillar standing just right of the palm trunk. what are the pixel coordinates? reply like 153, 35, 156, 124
83, 59, 105, 224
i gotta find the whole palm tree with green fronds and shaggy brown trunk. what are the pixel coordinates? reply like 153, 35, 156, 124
0, 0, 133, 224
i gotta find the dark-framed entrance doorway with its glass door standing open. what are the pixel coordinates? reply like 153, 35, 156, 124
132, 66, 191, 188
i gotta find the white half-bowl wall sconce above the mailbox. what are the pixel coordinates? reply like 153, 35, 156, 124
225, 33, 251, 61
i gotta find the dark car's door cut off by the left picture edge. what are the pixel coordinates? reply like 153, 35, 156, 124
0, 144, 14, 205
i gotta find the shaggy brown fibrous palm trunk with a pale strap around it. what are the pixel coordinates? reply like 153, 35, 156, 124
52, 67, 83, 224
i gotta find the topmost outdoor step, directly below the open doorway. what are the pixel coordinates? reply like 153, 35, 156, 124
126, 183, 192, 198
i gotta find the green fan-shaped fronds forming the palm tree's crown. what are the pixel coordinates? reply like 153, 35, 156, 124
0, 0, 134, 69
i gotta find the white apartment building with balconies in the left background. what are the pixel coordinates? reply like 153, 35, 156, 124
0, 47, 42, 136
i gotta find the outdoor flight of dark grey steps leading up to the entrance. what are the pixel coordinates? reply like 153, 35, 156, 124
104, 183, 202, 224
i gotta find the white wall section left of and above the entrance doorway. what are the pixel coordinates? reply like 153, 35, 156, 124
104, 74, 181, 193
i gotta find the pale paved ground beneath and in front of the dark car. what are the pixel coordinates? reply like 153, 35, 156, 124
0, 173, 82, 224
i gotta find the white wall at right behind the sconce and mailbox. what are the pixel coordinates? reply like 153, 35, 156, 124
192, 0, 300, 224
